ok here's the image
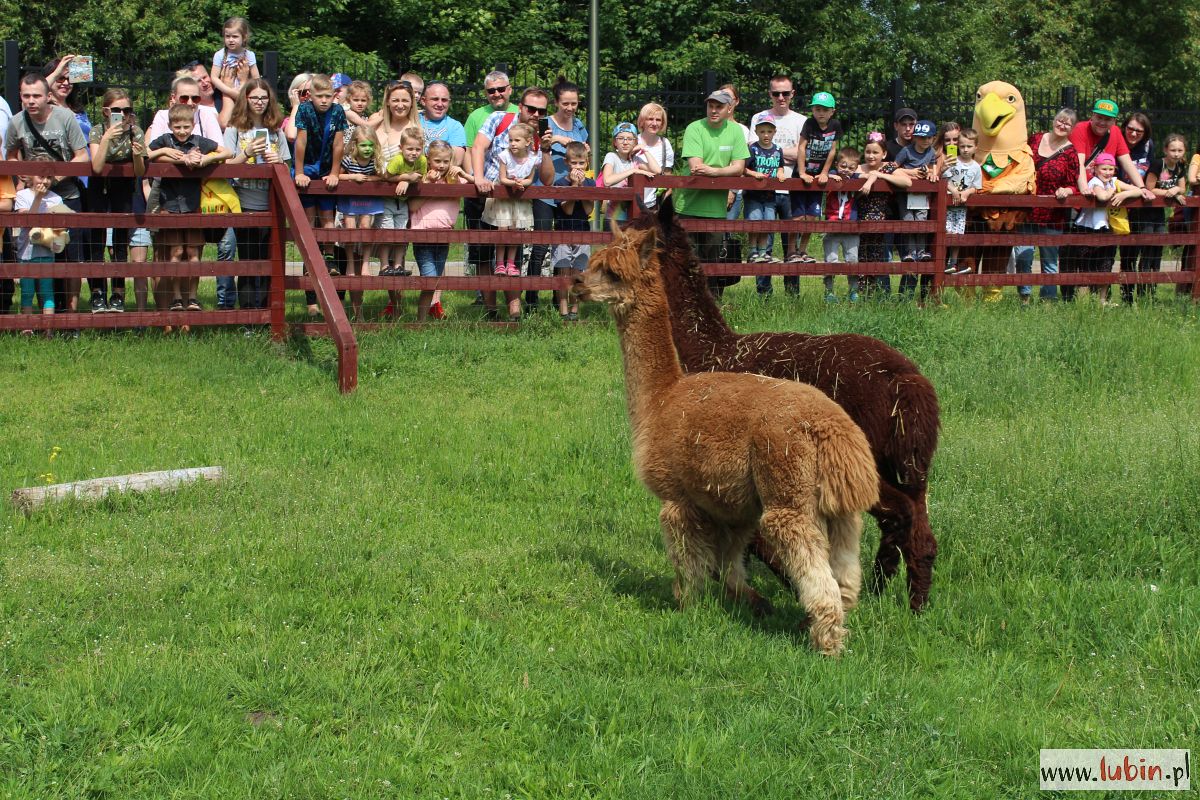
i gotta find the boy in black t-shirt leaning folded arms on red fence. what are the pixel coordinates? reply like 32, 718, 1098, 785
146, 103, 233, 311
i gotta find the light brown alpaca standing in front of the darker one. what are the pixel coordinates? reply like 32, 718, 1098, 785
576, 225, 878, 655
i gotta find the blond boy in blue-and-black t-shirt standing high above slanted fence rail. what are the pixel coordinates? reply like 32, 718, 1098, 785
295, 76, 347, 317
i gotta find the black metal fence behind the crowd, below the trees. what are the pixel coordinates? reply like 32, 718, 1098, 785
4, 41, 1200, 151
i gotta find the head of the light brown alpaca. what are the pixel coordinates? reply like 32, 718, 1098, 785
574, 221, 662, 320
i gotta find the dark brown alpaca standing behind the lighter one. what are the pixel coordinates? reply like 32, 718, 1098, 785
629, 199, 938, 610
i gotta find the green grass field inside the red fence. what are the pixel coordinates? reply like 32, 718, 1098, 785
0, 281, 1200, 800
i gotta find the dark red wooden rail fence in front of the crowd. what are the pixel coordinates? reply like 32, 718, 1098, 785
0, 161, 1200, 392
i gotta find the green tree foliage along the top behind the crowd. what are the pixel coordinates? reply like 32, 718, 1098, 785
0, 0, 1200, 104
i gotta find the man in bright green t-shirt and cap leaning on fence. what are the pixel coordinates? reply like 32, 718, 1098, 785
674, 89, 750, 283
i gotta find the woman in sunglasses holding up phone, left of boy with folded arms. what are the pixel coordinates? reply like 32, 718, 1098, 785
88, 89, 150, 312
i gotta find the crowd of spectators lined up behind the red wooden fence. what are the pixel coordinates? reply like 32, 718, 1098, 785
0, 28, 1200, 328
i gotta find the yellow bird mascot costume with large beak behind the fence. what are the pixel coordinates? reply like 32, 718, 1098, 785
972, 80, 1037, 301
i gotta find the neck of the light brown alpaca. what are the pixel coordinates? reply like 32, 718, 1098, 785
617, 284, 683, 427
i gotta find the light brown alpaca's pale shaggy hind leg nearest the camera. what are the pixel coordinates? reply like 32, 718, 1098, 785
760, 507, 846, 655
